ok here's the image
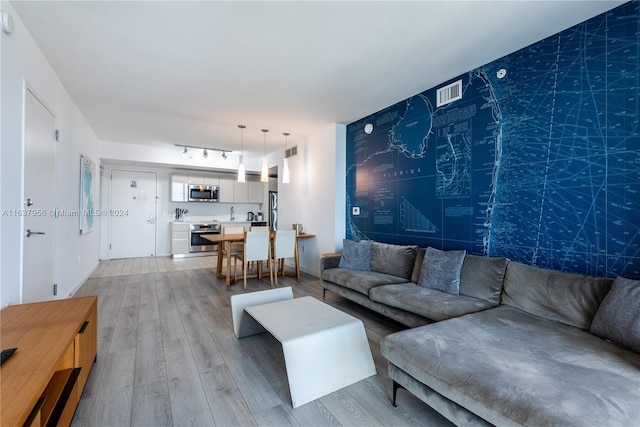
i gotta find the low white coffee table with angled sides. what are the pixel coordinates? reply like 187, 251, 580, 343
231, 288, 376, 408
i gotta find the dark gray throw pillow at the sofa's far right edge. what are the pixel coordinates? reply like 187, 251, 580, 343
589, 277, 640, 353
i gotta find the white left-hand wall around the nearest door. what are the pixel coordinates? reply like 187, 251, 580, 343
0, 2, 100, 307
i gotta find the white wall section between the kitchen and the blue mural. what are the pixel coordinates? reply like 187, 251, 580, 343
278, 124, 346, 277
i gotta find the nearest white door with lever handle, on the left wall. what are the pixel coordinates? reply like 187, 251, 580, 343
21, 90, 56, 303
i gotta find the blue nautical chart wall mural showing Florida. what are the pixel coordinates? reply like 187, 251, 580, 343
346, 2, 640, 277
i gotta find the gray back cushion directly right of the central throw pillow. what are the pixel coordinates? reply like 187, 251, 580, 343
460, 254, 509, 305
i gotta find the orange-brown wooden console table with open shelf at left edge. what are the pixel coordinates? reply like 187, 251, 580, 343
0, 296, 98, 427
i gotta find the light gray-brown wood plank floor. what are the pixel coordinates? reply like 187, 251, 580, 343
73, 257, 450, 426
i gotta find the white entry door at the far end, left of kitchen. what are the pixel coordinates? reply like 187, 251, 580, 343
105, 170, 157, 259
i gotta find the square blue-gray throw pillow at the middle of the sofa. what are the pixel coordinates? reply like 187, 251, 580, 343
418, 247, 467, 295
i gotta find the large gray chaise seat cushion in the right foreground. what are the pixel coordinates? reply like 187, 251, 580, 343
381, 305, 640, 426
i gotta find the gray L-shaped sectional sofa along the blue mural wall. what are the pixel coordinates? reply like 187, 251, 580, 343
321, 242, 640, 427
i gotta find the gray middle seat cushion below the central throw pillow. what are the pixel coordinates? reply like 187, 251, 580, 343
369, 283, 497, 321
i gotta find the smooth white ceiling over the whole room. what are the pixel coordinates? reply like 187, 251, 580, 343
11, 0, 624, 156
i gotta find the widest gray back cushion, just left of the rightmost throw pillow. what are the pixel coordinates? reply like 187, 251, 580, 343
502, 261, 613, 330
